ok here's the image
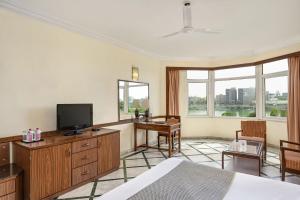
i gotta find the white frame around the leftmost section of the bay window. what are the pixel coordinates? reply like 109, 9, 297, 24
185, 70, 210, 117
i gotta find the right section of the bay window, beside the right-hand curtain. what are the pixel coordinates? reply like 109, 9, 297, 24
263, 59, 288, 118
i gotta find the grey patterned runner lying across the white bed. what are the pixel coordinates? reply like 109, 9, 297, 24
128, 161, 234, 200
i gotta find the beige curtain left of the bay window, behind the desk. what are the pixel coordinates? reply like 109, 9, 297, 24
167, 70, 179, 116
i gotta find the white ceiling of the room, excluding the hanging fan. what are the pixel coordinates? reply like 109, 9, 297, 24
0, 0, 300, 60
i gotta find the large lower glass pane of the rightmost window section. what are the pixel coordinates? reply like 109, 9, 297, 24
265, 76, 288, 117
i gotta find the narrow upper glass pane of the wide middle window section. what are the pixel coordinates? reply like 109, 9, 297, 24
215, 66, 255, 78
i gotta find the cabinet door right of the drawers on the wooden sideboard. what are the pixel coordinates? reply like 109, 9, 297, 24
98, 132, 120, 175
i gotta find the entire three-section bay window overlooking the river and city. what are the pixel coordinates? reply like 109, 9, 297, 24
183, 59, 288, 120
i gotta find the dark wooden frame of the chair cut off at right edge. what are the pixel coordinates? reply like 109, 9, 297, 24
280, 140, 300, 181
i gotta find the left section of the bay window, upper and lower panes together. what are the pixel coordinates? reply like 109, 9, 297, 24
187, 70, 208, 115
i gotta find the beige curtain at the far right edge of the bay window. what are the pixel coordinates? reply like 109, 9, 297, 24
287, 56, 300, 143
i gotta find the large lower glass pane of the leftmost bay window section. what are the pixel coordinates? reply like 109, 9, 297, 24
188, 83, 207, 115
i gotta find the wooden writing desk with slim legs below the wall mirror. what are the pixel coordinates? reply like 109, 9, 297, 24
134, 121, 181, 158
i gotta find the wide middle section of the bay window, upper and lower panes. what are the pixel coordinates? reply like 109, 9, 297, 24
215, 67, 256, 117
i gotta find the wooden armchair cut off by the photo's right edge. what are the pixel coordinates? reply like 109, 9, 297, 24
280, 140, 300, 181
